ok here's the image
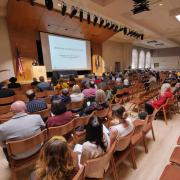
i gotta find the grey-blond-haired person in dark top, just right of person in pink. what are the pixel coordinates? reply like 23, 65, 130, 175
83, 89, 109, 115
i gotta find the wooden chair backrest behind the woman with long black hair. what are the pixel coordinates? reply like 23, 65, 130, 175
85, 140, 117, 176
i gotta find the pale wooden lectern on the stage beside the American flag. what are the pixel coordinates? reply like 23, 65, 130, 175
32, 66, 47, 81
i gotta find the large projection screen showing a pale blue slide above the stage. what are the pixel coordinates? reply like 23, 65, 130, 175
41, 33, 91, 71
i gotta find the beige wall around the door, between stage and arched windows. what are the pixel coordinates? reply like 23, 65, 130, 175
102, 41, 131, 71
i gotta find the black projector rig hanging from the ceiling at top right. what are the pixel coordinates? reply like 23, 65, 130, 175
131, 0, 150, 14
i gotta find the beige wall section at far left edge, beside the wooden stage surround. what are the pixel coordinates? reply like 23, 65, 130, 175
0, 17, 14, 82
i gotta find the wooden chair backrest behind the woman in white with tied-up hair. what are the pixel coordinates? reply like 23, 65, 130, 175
115, 129, 134, 151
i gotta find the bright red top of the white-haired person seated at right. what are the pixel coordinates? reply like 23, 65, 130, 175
152, 90, 173, 109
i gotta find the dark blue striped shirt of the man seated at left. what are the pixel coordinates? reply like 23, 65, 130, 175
26, 99, 47, 113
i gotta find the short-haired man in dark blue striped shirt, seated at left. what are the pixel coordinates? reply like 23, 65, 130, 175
26, 89, 47, 113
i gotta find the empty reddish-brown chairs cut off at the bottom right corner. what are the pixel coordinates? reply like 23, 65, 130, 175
160, 137, 180, 180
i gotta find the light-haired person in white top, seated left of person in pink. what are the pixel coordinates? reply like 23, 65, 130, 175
70, 85, 84, 102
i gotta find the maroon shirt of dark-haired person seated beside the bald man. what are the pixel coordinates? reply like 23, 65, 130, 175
48, 111, 73, 127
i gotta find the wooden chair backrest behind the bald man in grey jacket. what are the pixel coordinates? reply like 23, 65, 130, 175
6, 129, 47, 157
